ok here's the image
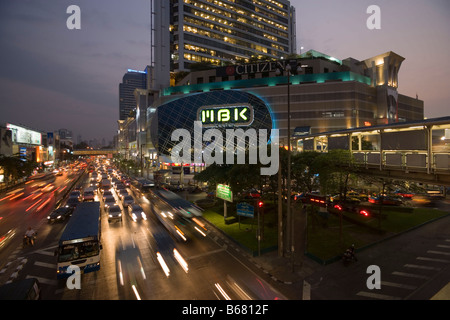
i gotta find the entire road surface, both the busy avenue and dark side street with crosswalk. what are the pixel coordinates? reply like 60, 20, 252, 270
0, 166, 450, 300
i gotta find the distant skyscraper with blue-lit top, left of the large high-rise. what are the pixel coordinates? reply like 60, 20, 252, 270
119, 69, 147, 120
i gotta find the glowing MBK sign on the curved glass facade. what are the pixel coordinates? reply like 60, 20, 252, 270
197, 104, 253, 127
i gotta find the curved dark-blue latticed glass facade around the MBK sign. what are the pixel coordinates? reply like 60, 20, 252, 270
149, 90, 273, 156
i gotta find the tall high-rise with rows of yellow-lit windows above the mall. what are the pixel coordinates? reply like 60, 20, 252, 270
163, 0, 296, 71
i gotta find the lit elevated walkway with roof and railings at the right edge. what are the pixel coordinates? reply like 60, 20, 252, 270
296, 117, 450, 186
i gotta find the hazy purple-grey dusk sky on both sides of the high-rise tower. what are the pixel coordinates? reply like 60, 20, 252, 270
0, 0, 450, 142
